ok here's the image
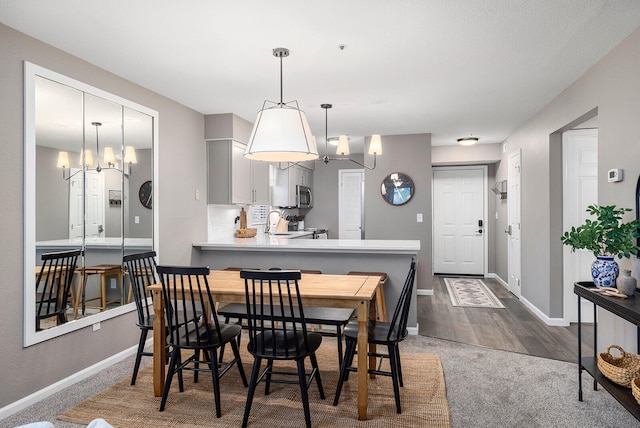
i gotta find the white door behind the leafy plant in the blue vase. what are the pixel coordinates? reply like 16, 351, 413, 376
562, 129, 598, 324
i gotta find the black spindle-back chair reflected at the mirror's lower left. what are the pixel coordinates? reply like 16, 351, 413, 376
36, 249, 81, 331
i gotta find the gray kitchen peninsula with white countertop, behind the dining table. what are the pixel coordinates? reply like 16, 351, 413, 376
192, 236, 420, 334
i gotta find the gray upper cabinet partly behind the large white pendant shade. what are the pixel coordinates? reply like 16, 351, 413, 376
207, 139, 269, 205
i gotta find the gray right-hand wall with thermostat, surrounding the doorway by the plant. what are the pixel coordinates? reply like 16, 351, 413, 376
496, 24, 640, 348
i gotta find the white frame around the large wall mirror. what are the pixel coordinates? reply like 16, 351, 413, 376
23, 61, 160, 347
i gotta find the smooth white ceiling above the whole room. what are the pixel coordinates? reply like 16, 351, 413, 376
0, 0, 640, 154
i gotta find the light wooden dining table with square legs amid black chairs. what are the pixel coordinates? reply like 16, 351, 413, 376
148, 270, 381, 420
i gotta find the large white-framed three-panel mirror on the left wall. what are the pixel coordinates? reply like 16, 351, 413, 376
24, 62, 158, 346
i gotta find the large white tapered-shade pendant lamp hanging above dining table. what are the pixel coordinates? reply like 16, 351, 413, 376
244, 48, 318, 162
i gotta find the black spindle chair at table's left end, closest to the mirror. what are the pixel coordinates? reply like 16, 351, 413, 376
122, 251, 161, 385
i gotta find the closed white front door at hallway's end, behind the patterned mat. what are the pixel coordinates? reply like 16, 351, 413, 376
433, 166, 487, 275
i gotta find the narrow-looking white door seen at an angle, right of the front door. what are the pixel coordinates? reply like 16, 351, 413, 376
506, 150, 522, 298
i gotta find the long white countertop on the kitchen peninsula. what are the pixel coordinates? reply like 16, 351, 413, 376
193, 232, 420, 254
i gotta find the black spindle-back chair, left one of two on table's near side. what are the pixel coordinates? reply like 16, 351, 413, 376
156, 266, 247, 418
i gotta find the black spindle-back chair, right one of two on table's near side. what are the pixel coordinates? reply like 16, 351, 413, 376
240, 270, 325, 427
